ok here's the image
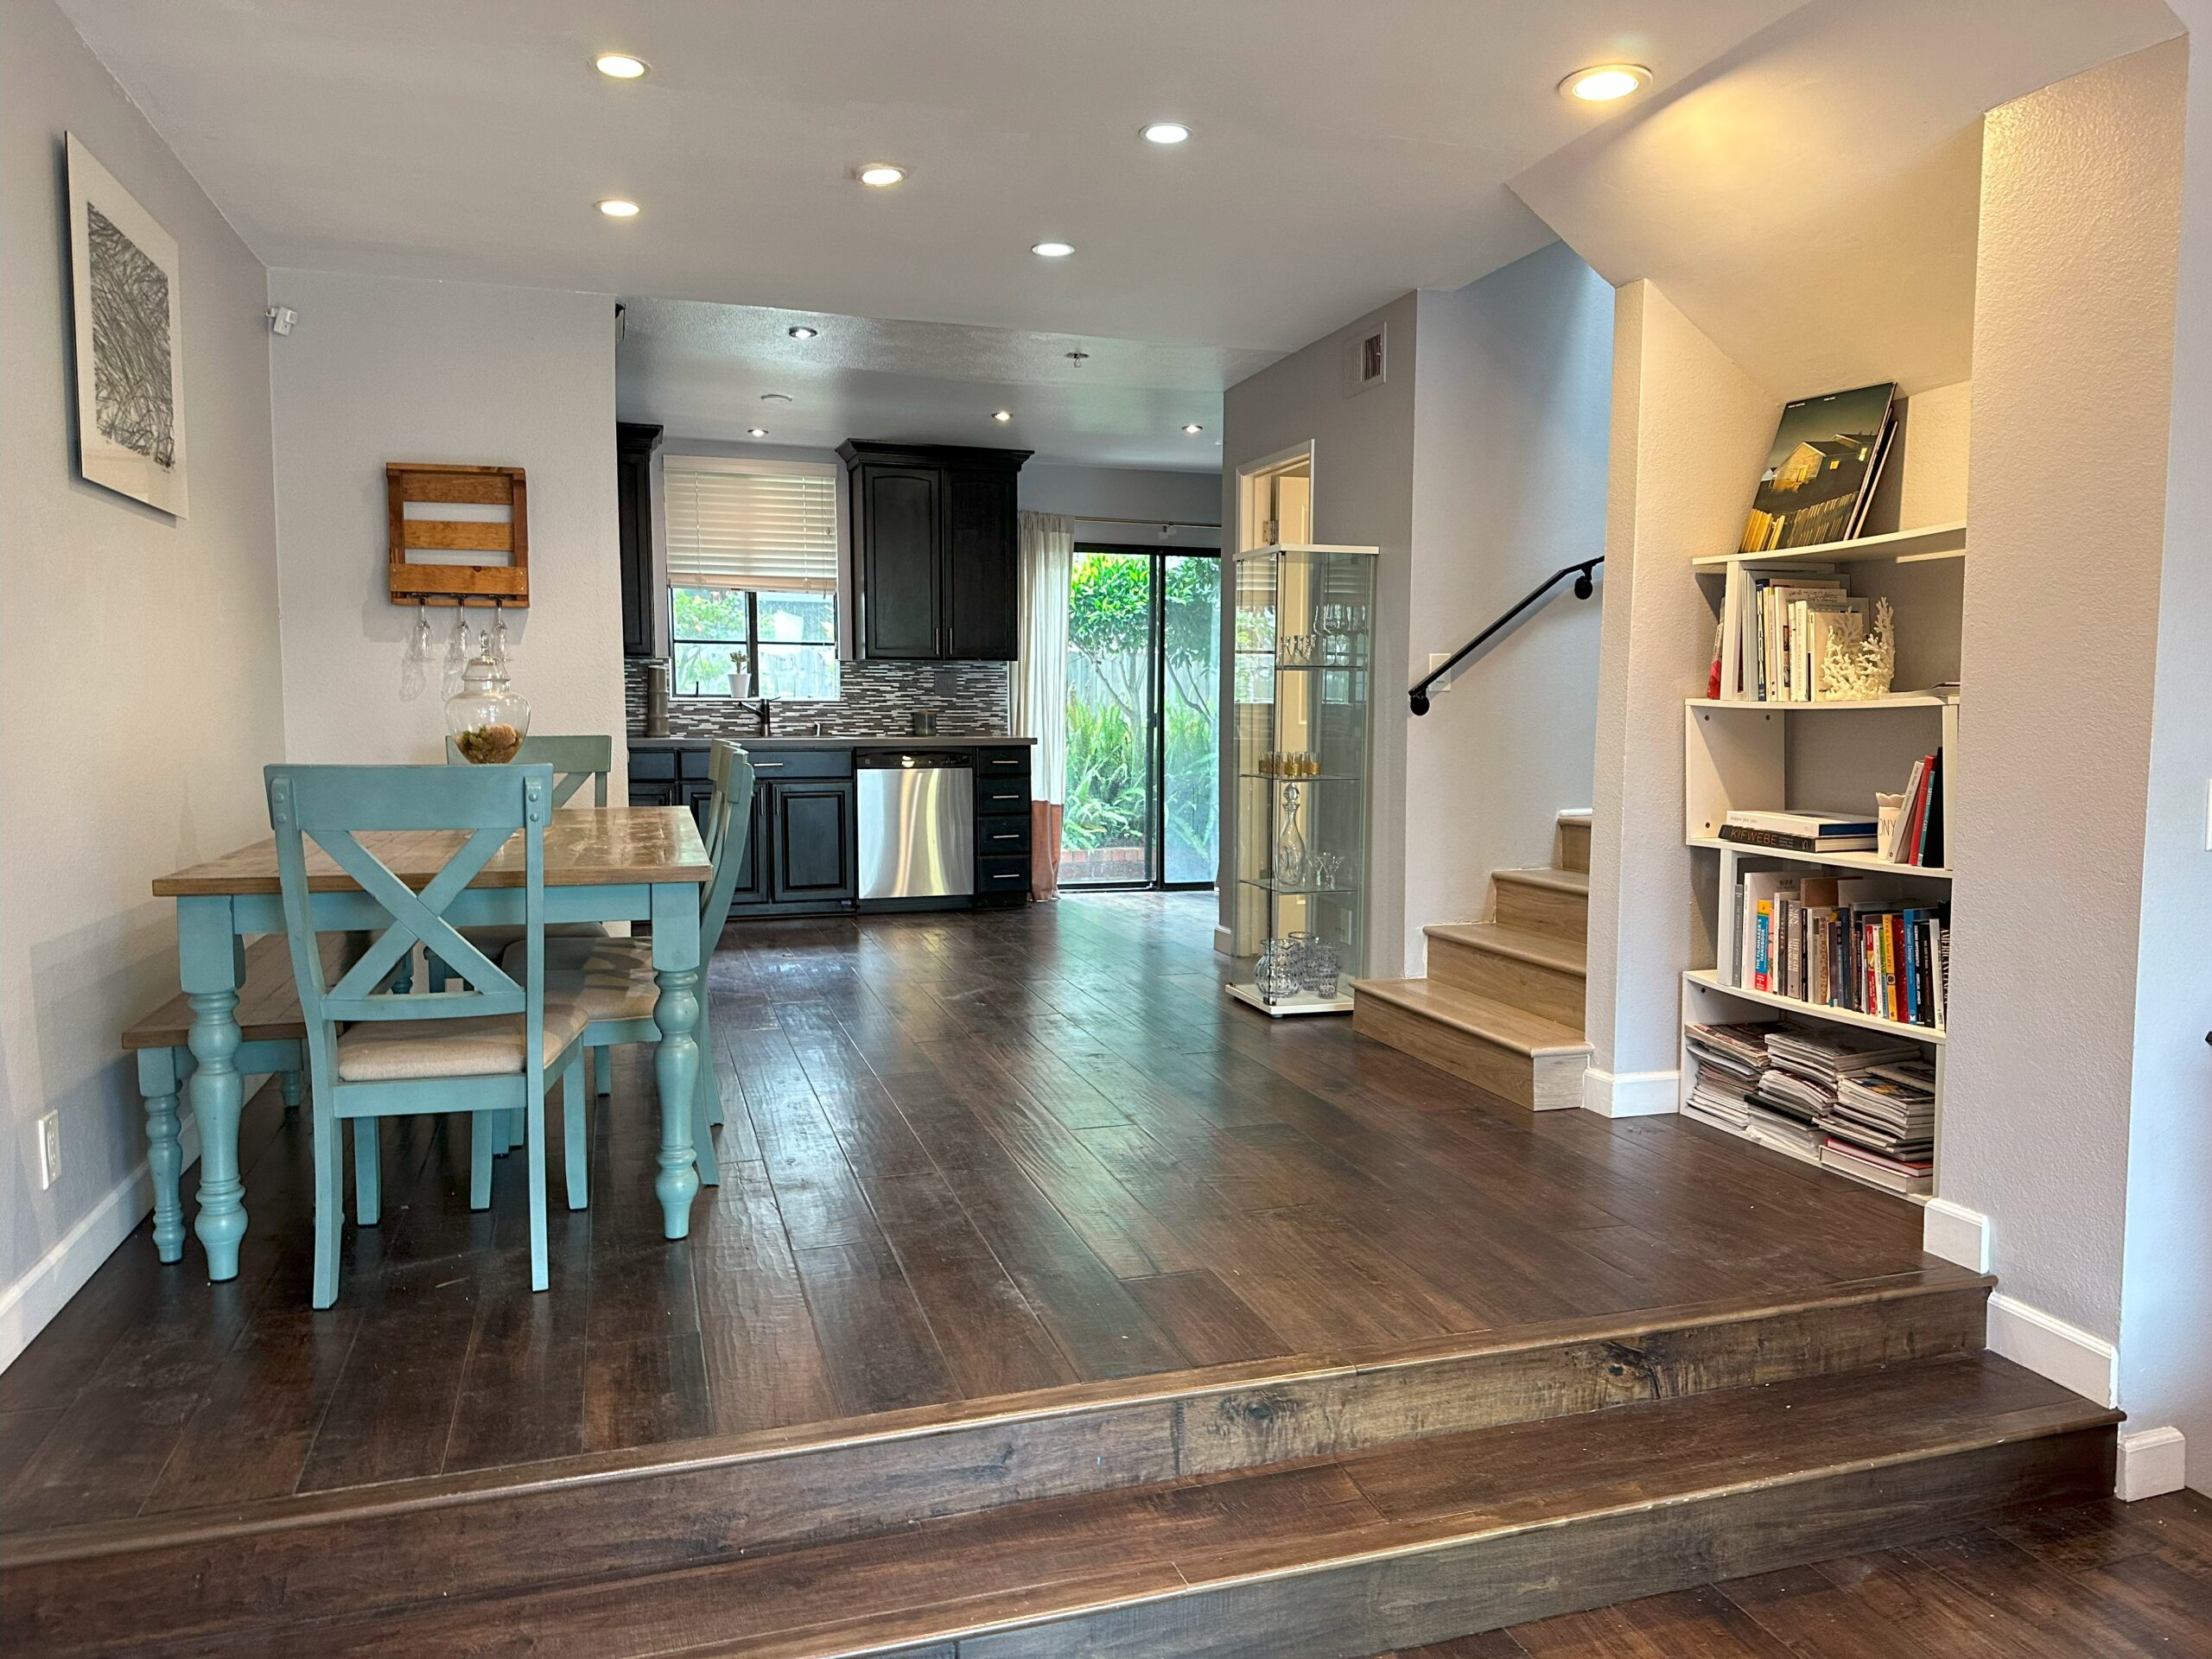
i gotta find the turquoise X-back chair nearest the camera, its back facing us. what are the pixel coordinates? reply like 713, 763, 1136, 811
265, 766, 588, 1307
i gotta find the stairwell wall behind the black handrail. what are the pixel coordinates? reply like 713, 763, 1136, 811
1407, 244, 1612, 973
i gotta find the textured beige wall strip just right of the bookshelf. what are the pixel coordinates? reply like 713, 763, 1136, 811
1938, 42, 2203, 1343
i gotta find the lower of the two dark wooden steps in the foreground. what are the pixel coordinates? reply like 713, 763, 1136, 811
147, 1354, 2119, 1659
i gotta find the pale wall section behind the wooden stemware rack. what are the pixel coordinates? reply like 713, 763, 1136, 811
268, 270, 624, 774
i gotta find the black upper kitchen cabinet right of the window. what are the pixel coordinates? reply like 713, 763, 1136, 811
838, 442, 1031, 661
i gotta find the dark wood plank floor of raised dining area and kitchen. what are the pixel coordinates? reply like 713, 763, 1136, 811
0, 893, 1923, 1531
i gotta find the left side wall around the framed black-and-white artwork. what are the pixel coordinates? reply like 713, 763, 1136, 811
0, 0, 283, 1363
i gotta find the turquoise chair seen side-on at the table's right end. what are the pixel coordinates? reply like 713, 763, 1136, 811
509, 739, 754, 1210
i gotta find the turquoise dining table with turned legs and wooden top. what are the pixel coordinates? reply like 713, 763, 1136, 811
153, 807, 715, 1281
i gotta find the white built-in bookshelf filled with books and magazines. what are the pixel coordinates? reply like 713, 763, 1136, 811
1679, 522, 1967, 1190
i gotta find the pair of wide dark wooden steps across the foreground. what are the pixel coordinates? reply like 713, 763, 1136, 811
0, 1265, 2119, 1659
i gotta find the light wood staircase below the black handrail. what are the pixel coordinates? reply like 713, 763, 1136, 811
1351, 812, 1591, 1113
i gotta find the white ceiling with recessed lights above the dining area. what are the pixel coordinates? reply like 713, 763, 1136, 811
62, 0, 1796, 352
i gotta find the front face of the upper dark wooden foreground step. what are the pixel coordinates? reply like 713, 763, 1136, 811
0, 1263, 1993, 1655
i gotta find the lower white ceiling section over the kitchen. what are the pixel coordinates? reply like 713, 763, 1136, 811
615, 299, 1274, 471
